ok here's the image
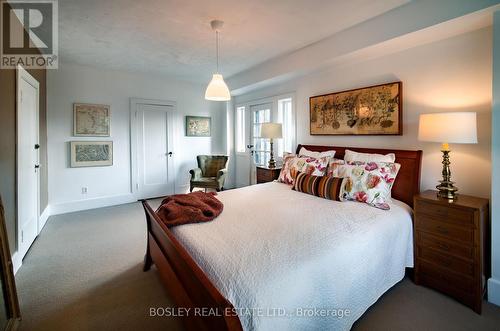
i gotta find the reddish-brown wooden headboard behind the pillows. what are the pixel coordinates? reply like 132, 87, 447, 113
296, 145, 422, 208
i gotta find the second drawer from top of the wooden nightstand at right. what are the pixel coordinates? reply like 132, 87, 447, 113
415, 215, 474, 245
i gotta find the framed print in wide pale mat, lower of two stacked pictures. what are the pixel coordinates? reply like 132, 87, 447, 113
70, 141, 113, 168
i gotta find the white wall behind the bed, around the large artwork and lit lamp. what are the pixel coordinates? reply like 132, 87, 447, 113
235, 28, 492, 198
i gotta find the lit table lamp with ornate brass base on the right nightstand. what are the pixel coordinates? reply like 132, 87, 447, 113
418, 112, 477, 200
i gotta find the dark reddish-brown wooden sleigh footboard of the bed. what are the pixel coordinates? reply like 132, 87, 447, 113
142, 200, 243, 331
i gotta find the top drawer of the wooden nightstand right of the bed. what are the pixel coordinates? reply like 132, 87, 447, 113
415, 201, 474, 228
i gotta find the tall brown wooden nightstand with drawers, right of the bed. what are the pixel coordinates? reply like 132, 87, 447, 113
414, 191, 490, 314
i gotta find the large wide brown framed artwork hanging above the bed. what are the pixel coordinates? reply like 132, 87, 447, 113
309, 82, 403, 135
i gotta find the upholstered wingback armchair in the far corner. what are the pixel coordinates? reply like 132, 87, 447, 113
189, 155, 228, 192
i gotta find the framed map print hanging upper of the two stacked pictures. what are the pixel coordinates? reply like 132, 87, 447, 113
73, 103, 110, 137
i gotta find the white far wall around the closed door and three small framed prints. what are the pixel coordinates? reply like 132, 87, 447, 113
47, 63, 227, 214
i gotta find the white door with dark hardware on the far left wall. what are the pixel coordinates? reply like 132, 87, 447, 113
17, 68, 41, 257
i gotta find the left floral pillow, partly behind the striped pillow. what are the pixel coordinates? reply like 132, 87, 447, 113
278, 154, 330, 185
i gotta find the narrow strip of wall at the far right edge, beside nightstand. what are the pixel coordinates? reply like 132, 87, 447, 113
488, 11, 500, 306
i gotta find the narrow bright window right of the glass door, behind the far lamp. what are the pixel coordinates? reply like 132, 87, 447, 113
276, 98, 295, 157
